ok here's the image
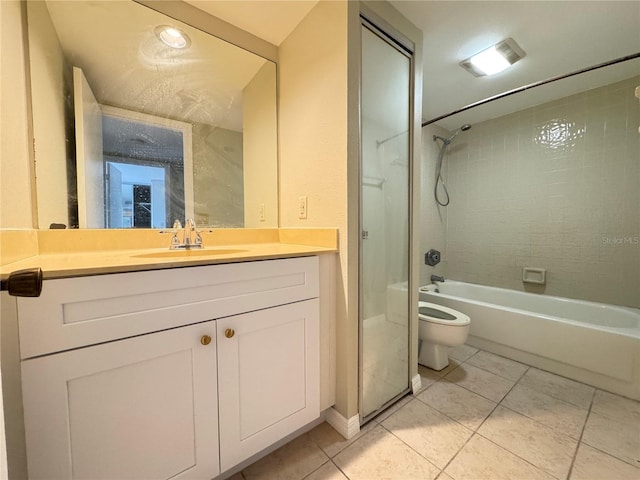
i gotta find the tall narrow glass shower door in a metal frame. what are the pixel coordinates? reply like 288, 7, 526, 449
360, 20, 411, 418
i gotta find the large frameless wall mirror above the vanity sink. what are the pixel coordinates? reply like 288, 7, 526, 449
27, 0, 278, 228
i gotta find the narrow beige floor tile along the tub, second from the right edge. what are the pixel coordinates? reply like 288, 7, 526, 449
520, 368, 595, 408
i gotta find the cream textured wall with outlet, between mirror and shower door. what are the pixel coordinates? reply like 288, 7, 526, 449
279, 1, 358, 418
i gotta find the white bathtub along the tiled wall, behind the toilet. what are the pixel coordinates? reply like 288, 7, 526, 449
420, 280, 640, 400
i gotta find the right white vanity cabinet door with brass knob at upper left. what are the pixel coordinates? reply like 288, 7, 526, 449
217, 299, 320, 471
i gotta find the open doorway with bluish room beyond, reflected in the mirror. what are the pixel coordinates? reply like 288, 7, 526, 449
102, 108, 193, 228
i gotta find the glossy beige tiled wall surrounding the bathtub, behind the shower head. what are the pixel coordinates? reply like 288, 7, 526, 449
438, 76, 640, 307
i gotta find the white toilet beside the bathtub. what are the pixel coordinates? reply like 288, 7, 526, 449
418, 302, 471, 370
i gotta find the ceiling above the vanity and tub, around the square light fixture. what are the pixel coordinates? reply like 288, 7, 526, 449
187, 0, 640, 129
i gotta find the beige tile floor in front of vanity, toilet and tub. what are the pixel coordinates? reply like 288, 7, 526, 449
232, 345, 640, 480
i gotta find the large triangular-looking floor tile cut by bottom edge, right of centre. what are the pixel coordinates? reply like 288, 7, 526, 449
445, 434, 553, 480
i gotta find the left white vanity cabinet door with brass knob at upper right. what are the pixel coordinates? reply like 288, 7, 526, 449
22, 322, 220, 480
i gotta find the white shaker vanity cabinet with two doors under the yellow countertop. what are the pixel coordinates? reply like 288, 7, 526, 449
18, 257, 320, 480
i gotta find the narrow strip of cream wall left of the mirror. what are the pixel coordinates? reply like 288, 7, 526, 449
0, 0, 34, 228
